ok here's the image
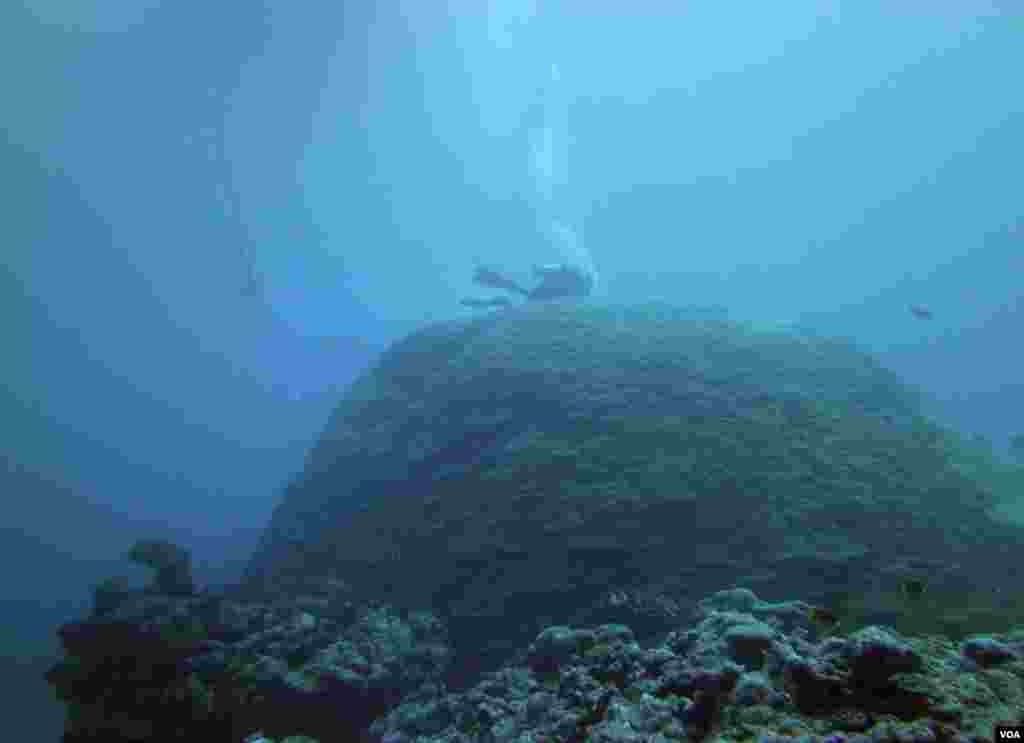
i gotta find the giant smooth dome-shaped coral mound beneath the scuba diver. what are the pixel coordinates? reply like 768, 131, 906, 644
243, 303, 1019, 650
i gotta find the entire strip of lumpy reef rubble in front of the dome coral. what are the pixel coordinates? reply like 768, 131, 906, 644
47, 548, 1024, 743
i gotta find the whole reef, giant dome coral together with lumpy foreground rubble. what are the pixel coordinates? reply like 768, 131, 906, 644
41, 304, 1024, 743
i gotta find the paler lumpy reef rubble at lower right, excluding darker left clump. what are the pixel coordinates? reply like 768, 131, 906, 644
372, 588, 1024, 743
